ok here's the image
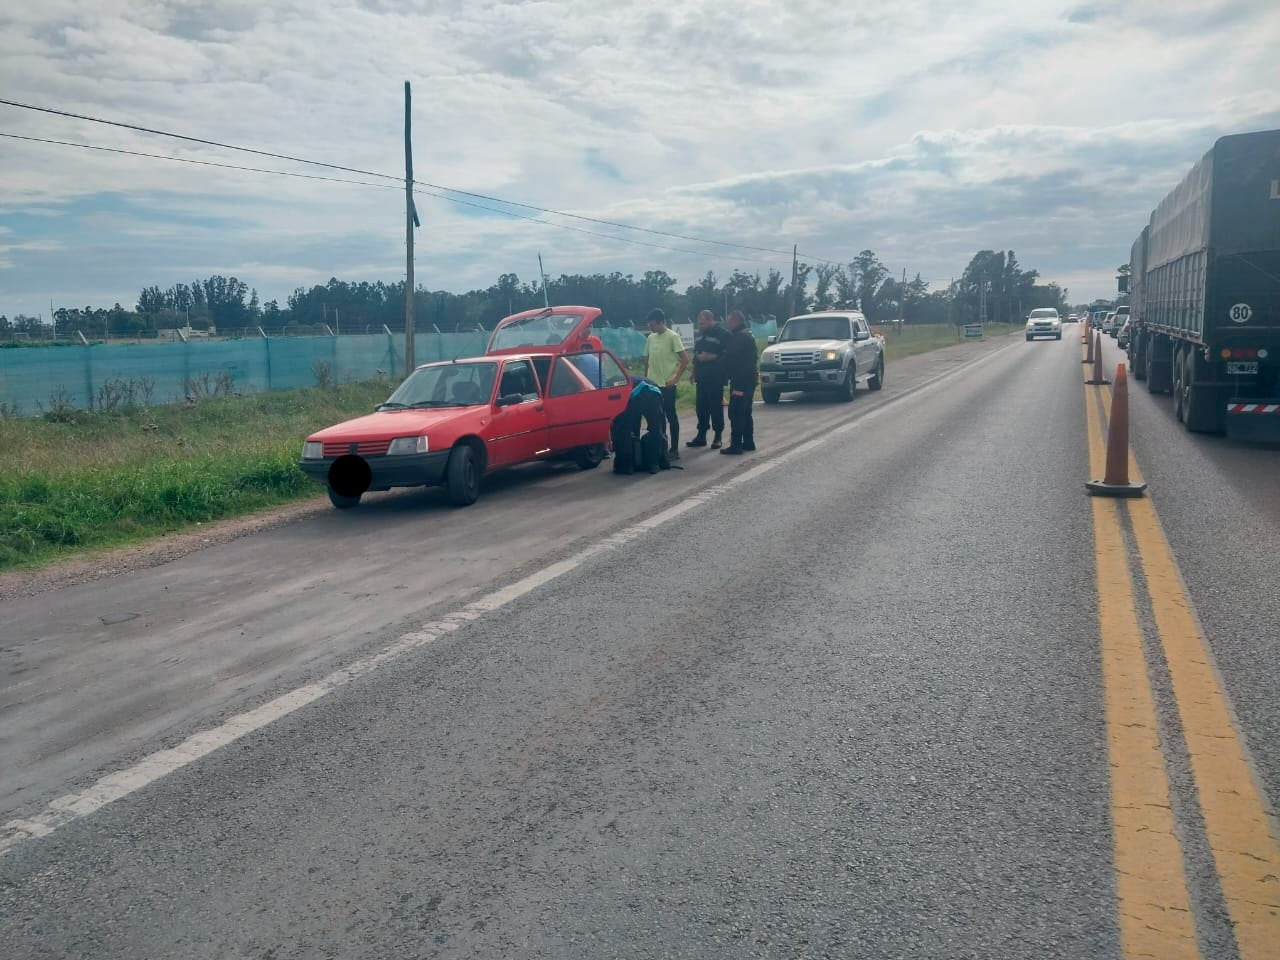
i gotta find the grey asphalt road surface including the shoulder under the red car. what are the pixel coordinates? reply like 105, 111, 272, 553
0, 328, 1280, 960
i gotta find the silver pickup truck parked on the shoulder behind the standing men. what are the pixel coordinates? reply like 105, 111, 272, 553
760, 310, 884, 403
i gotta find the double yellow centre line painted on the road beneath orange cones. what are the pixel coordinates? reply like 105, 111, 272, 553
1085, 366, 1280, 960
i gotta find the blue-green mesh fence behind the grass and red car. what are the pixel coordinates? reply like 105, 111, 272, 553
0, 329, 644, 416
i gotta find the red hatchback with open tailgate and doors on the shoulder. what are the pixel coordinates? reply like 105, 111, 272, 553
300, 307, 631, 509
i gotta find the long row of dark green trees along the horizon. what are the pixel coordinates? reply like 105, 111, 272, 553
0, 250, 1068, 337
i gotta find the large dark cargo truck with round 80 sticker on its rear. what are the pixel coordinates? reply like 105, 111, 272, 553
1129, 131, 1280, 442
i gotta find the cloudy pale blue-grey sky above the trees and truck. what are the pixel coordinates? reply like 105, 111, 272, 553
0, 0, 1280, 315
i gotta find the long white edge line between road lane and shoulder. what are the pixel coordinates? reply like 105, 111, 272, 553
0, 344, 1012, 856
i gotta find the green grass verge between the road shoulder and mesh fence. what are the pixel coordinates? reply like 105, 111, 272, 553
0, 325, 1021, 570
